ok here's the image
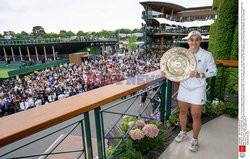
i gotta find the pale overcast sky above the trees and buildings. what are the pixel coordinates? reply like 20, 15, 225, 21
0, 0, 212, 33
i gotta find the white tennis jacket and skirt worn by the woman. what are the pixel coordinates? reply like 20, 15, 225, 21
177, 47, 217, 105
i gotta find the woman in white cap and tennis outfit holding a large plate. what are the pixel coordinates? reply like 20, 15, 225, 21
161, 31, 217, 152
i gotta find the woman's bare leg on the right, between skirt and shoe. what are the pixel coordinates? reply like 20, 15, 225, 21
191, 104, 202, 139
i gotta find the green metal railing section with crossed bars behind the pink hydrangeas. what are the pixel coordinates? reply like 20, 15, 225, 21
96, 81, 166, 158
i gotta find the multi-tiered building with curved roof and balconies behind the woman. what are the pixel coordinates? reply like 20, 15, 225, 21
140, 1, 216, 56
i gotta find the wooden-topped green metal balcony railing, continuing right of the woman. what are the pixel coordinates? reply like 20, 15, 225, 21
0, 61, 238, 159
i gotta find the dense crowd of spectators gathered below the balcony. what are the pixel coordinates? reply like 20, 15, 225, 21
0, 52, 160, 115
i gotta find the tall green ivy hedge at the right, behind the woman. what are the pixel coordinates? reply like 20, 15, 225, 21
208, 0, 238, 97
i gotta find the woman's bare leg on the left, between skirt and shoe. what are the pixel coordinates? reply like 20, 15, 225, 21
178, 101, 189, 132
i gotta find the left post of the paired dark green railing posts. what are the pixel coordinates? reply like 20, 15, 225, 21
84, 112, 93, 159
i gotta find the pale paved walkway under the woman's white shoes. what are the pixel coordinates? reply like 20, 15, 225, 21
158, 115, 238, 159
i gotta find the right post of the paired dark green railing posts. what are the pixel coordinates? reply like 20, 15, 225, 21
94, 107, 105, 159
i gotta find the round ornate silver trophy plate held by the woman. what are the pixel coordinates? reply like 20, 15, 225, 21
160, 47, 197, 82
